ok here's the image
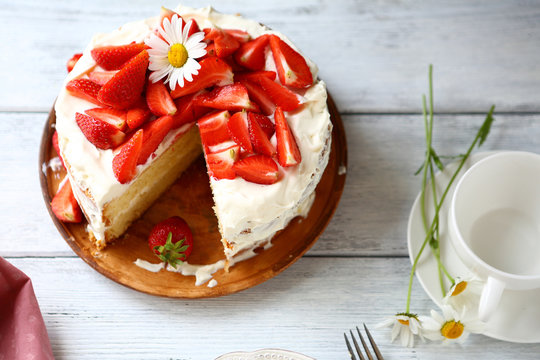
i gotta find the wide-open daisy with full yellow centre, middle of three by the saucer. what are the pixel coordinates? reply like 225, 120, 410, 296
420, 305, 484, 345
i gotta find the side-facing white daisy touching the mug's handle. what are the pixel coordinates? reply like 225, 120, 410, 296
443, 277, 484, 312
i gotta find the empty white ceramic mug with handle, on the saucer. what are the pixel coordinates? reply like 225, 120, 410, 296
448, 151, 540, 321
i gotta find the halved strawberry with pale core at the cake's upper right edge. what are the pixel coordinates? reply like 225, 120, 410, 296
270, 35, 313, 88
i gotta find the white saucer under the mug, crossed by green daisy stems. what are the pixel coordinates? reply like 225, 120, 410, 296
407, 152, 540, 343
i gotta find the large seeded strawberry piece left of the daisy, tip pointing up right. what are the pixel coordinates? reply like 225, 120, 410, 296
98, 50, 148, 109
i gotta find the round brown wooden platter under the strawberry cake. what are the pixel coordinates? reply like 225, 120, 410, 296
39, 97, 347, 298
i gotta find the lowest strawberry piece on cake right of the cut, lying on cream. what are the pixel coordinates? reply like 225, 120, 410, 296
233, 155, 280, 185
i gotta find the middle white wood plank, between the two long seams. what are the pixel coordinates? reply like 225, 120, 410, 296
0, 113, 540, 256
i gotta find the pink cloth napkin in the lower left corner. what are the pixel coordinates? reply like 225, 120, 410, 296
0, 257, 54, 360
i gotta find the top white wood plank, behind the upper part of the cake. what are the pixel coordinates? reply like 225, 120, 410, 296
0, 0, 540, 113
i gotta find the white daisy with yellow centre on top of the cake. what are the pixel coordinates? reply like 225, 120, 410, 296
144, 14, 206, 90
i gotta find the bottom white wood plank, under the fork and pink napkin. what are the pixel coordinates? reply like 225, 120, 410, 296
8, 258, 540, 360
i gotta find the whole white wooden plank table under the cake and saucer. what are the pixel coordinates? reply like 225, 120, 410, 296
0, 0, 540, 359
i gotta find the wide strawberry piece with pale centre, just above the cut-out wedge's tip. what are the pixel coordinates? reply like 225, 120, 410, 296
194, 83, 259, 111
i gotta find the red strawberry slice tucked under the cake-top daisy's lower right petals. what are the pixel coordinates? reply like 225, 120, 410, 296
171, 57, 233, 99
